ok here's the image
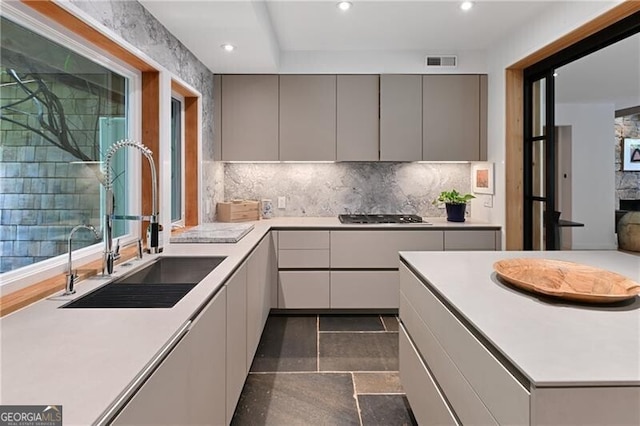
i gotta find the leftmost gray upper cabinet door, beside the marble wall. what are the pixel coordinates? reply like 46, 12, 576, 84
222, 75, 278, 161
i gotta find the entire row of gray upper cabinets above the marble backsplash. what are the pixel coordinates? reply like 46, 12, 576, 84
214, 74, 487, 161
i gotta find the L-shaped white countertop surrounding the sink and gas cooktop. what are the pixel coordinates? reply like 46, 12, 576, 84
0, 217, 500, 425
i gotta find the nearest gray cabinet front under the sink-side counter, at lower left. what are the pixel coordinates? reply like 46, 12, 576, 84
112, 288, 226, 425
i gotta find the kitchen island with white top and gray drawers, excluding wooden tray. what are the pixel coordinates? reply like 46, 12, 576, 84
400, 251, 640, 425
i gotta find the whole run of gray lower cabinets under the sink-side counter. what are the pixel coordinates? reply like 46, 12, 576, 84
113, 233, 277, 425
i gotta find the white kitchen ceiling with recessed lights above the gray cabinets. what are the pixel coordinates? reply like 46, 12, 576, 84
141, 0, 549, 73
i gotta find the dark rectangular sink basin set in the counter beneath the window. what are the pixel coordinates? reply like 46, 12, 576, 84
61, 257, 225, 308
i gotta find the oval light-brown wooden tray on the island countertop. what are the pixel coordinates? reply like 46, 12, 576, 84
493, 258, 640, 303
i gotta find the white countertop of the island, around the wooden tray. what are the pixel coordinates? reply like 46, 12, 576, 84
400, 251, 640, 387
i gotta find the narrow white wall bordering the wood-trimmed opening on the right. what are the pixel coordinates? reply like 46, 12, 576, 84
480, 1, 621, 247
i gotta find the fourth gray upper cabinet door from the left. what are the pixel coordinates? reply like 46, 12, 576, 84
380, 74, 422, 161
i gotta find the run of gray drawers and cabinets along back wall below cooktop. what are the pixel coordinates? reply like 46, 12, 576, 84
277, 228, 500, 310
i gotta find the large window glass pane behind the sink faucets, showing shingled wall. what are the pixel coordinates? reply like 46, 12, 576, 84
0, 17, 128, 272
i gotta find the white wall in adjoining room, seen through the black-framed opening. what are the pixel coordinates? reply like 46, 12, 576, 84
556, 104, 616, 250
